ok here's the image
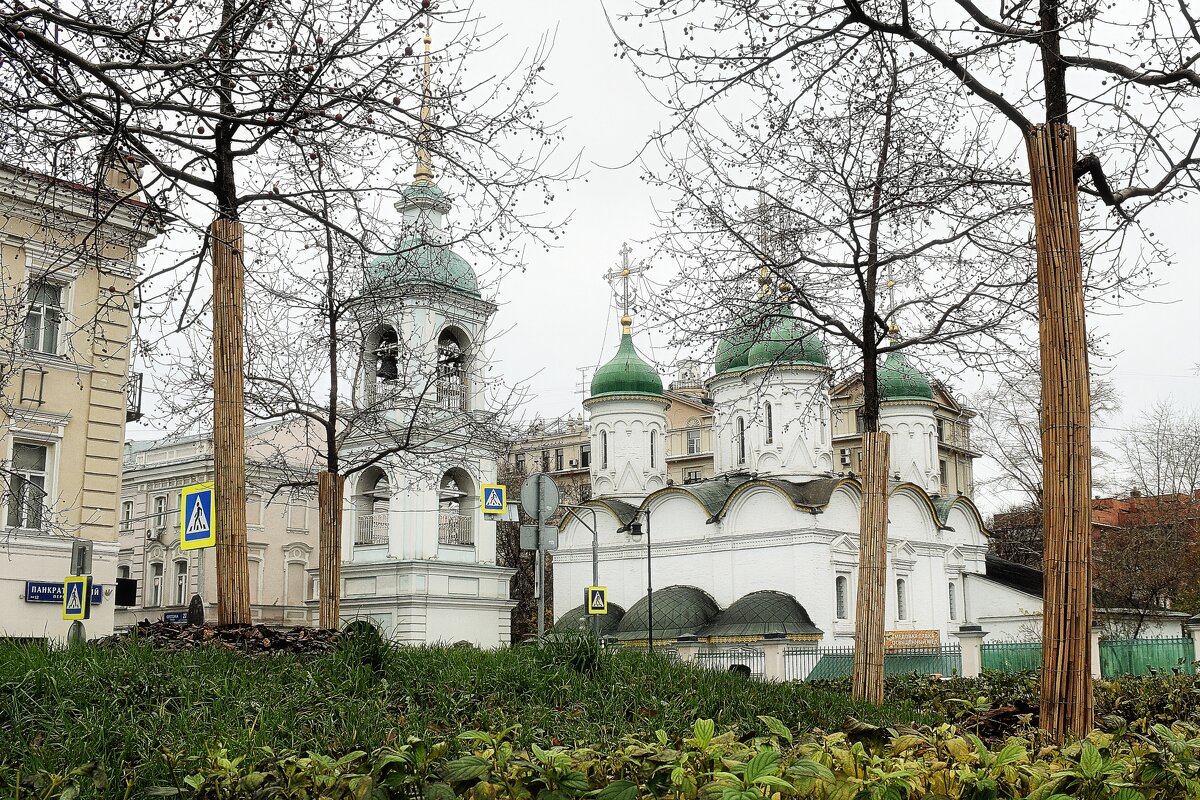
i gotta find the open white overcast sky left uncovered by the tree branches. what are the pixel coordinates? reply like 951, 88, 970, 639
476, 0, 1200, 506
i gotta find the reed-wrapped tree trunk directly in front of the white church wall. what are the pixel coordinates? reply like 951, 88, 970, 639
854, 431, 890, 704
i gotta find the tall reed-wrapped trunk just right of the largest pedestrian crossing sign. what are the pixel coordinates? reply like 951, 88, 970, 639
211, 219, 250, 625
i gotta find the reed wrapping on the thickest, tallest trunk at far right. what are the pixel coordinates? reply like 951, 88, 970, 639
1025, 122, 1093, 740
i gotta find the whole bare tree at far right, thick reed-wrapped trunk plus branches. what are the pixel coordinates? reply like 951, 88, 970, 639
624, 0, 1200, 736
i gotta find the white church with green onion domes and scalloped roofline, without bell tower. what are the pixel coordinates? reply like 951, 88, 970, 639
554, 297, 1178, 646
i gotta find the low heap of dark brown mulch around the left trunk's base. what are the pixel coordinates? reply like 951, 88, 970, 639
95, 620, 338, 655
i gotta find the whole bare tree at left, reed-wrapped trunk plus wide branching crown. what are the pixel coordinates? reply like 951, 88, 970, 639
0, 0, 571, 622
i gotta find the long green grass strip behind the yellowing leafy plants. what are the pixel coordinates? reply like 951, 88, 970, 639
0, 643, 930, 796
